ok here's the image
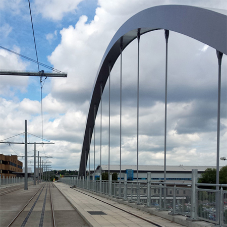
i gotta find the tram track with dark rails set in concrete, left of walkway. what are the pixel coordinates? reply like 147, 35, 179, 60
7, 183, 87, 227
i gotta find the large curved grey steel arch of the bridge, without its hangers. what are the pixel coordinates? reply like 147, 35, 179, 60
79, 5, 227, 176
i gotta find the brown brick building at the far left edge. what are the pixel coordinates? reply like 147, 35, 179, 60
0, 154, 23, 178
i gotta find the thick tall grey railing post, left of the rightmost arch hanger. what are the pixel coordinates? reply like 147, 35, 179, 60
191, 169, 198, 220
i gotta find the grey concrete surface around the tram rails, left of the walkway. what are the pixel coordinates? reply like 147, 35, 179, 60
0, 183, 88, 227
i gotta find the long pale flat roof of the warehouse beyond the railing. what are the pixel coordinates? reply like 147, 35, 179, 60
96, 165, 222, 172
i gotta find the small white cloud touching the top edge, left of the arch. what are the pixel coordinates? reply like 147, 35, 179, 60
35, 0, 83, 20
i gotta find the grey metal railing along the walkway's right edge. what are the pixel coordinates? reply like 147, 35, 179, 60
61, 171, 227, 226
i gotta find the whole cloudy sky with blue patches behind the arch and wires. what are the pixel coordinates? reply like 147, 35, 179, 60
0, 0, 227, 170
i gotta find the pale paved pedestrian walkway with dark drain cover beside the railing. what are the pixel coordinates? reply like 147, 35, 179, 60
55, 182, 184, 227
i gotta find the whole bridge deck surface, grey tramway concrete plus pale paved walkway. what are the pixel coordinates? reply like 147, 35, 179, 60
0, 182, 214, 227
